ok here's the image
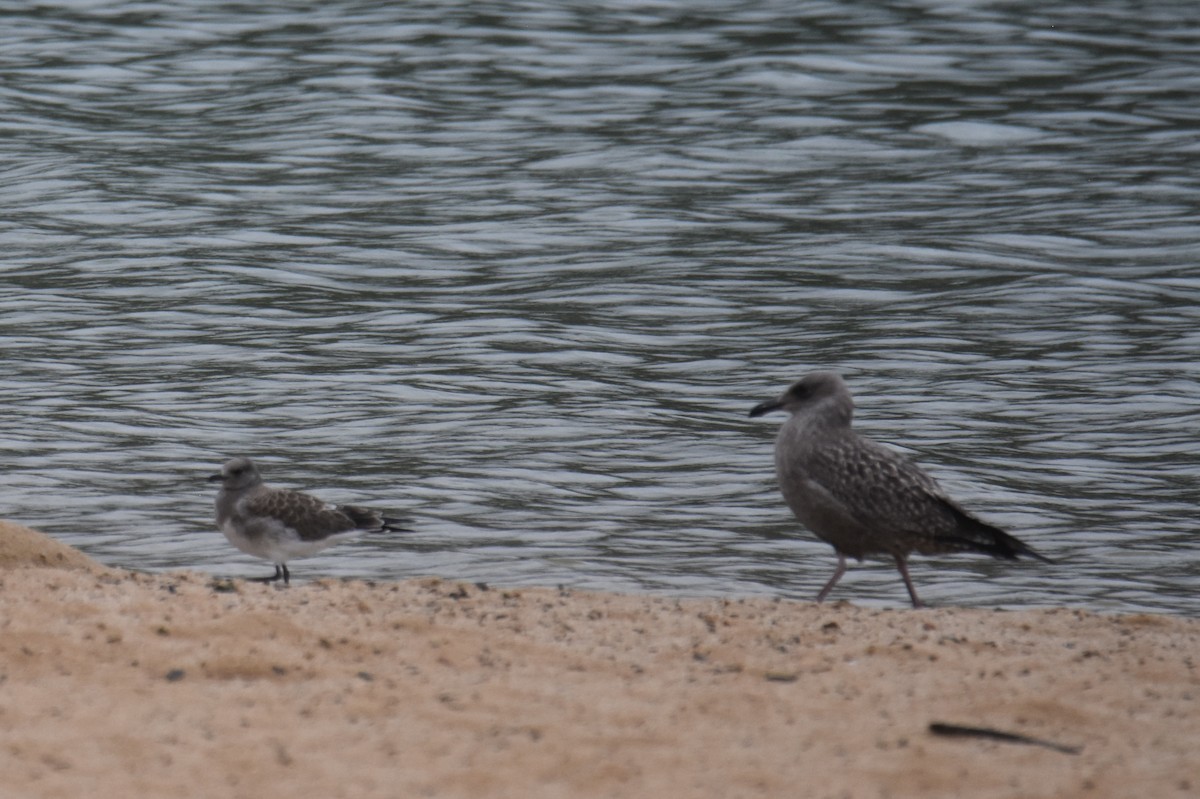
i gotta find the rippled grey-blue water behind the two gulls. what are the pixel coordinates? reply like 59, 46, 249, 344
0, 0, 1200, 613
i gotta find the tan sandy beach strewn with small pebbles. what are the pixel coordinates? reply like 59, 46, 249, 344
0, 523, 1200, 799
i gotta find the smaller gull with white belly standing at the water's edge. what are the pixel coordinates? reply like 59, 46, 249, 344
209, 457, 408, 584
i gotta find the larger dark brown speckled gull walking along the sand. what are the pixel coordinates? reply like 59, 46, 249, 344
750, 372, 1050, 607
